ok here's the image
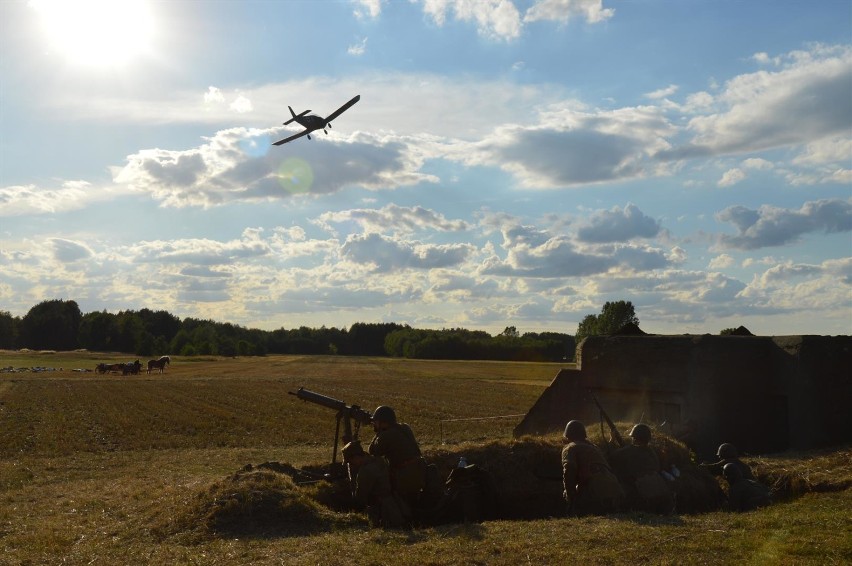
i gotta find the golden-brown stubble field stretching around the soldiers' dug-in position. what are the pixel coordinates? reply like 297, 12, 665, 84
0, 352, 852, 565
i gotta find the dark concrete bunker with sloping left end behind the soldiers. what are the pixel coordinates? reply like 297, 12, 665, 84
515, 335, 852, 457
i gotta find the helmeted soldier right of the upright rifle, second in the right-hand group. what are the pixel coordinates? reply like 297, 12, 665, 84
610, 423, 675, 515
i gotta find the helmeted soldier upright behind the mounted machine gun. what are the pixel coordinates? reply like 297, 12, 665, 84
368, 405, 426, 507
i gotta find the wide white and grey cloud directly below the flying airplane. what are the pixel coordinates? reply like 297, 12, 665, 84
113, 128, 434, 207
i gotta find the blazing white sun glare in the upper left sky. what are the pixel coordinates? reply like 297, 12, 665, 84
30, 0, 154, 67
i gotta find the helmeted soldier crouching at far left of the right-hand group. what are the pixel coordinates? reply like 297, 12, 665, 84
562, 420, 624, 516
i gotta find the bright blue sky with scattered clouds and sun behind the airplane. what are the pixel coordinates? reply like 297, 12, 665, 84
0, 0, 852, 335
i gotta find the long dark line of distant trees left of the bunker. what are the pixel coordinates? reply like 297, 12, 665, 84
0, 299, 575, 361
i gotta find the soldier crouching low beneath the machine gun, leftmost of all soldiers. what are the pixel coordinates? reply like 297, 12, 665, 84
343, 440, 411, 529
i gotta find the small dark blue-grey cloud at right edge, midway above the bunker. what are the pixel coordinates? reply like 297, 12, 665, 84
716, 199, 852, 250
